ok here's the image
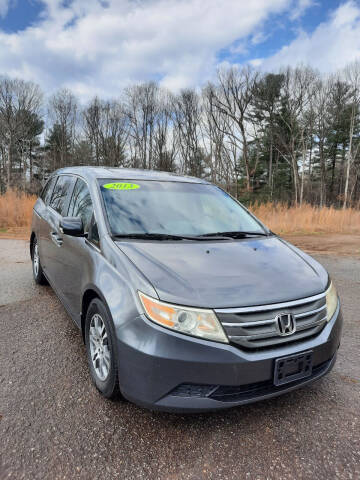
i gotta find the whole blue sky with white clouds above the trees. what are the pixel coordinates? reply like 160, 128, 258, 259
0, 0, 360, 102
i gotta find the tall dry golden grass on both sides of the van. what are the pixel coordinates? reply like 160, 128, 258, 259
0, 190, 360, 234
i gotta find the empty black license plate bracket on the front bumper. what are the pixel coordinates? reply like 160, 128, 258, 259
274, 350, 313, 386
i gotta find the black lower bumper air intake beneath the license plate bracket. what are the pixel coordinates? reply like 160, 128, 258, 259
170, 358, 333, 402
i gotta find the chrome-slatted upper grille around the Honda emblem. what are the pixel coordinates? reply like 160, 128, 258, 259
216, 293, 327, 349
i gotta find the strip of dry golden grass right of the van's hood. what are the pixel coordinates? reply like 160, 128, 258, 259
250, 203, 360, 234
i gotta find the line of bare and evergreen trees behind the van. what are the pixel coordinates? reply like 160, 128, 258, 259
0, 61, 360, 208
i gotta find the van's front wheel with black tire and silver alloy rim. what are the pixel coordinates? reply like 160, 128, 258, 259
85, 298, 120, 398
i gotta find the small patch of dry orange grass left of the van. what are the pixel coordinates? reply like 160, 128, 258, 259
0, 190, 36, 230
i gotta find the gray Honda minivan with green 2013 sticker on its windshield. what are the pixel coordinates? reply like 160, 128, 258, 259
30, 167, 342, 412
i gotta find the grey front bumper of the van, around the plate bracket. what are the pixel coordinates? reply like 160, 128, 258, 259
117, 306, 343, 412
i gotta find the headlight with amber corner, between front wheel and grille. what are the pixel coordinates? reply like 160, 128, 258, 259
138, 292, 229, 343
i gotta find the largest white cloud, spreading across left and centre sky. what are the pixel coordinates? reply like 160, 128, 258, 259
0, 0, 292, 100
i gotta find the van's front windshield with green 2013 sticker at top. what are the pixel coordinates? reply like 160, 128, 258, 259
99, 179, 264, 236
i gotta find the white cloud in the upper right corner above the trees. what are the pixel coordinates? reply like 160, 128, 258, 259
256, 1, 360, 72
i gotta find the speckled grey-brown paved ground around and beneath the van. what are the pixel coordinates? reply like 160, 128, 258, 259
0, 240, 360, 480
